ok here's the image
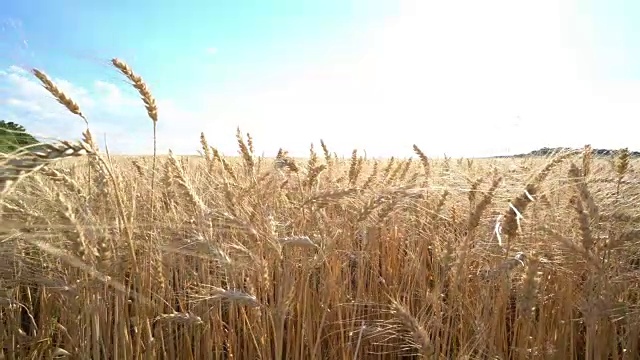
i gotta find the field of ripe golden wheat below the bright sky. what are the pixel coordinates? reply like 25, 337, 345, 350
0, 59, 640, 360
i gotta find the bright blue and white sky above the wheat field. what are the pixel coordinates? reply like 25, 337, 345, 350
0, 0, 640, 157
